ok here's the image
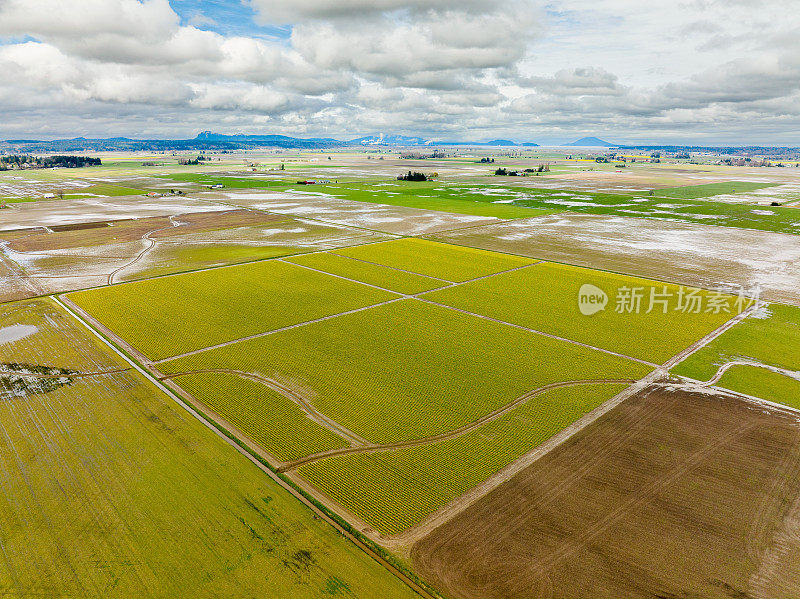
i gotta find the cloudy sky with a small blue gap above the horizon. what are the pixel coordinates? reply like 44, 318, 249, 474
0, 0, 800, 145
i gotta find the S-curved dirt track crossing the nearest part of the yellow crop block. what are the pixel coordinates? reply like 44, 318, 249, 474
278, 379, 636, 472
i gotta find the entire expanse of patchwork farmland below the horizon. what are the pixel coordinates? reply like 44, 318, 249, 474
0, 146, 800, 599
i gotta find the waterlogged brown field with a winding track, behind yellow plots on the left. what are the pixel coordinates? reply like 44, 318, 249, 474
0, 209, 390, 302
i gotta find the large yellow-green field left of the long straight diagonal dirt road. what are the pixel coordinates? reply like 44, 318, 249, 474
0, 300, 413, 599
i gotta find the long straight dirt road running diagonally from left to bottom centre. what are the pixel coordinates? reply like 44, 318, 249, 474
53, 296, 438, 599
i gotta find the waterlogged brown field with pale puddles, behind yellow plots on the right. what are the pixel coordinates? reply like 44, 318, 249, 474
430, 214, 800, 304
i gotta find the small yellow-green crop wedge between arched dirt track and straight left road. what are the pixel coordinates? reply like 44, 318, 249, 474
175, 372, 347, 461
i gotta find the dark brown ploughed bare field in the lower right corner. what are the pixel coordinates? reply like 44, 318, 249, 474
412, 386, 800, 599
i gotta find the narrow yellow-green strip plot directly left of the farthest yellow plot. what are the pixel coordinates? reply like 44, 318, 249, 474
287, 252, 448, 295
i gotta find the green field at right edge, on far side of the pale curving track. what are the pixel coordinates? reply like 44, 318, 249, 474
673, 304, 800, 381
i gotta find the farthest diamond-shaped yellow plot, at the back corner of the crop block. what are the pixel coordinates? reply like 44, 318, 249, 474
333, 238, 535, 282
